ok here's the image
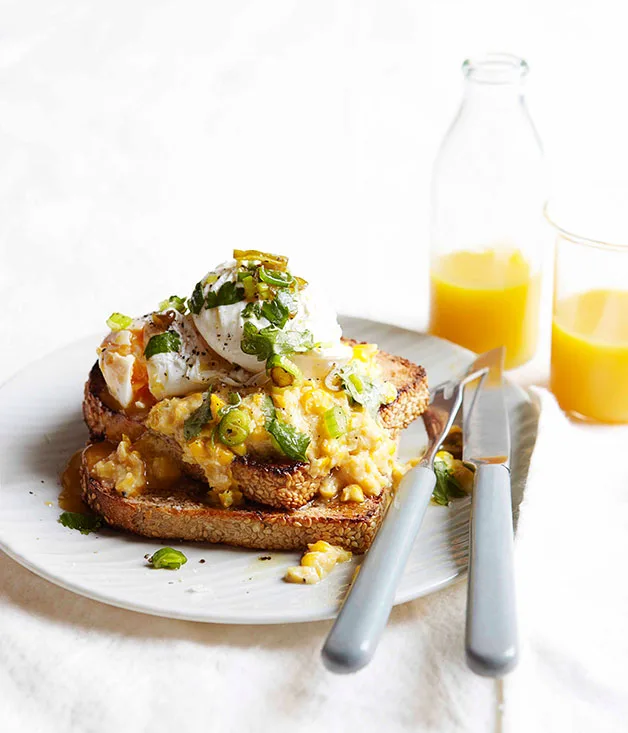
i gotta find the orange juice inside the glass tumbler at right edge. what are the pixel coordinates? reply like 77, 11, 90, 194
550, 290, 628, 423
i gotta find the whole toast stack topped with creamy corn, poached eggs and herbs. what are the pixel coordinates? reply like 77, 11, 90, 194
75, 251, 428, 552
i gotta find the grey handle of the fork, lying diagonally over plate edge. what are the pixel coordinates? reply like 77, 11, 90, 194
322, 466, 436, 674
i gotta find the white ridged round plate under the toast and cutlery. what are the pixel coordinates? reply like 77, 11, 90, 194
0, 318, 536, 624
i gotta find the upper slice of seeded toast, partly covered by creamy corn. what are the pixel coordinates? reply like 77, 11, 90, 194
83, 340, 429, 509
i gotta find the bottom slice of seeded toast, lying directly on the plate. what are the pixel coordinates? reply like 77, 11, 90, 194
81, 453, 390, 553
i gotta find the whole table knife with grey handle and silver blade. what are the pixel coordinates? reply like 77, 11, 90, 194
463, 347, 519, 677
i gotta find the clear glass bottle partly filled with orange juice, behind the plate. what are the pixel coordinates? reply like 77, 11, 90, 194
430, 54, 546, 369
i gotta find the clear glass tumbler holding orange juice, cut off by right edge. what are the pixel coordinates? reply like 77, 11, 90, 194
549, 199, 628, 423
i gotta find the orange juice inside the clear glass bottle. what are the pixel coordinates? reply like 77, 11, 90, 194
430, 247, 541, 369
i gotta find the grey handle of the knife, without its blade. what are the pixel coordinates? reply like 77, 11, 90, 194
466, 464, 519, 677
